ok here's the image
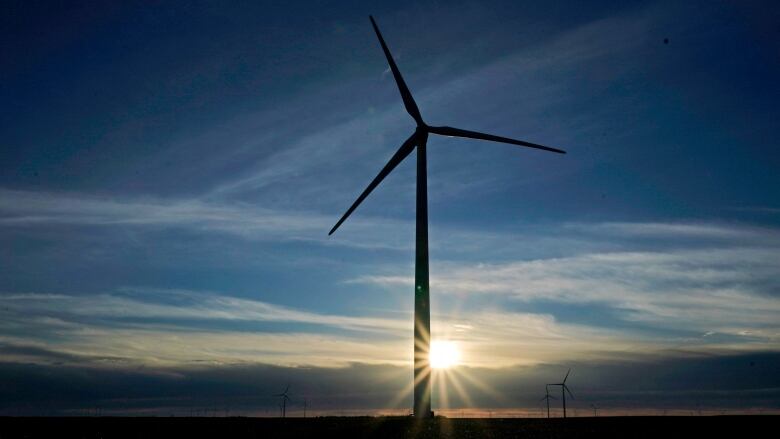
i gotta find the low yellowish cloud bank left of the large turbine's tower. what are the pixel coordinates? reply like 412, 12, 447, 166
0, 289, 408, 365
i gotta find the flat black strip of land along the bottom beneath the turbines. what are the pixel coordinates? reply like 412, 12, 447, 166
0, 416, 780, 439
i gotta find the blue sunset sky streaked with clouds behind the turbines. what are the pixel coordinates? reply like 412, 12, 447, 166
0, 1, 780, 416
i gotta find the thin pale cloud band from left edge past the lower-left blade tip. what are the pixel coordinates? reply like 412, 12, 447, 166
0, 189, 414, 248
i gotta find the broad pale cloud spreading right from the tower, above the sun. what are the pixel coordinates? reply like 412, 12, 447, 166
352, 223, 780, 354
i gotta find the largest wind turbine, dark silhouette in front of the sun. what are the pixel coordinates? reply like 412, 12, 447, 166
328, 16, 565, 418
